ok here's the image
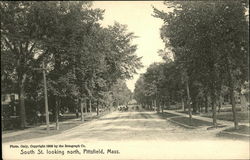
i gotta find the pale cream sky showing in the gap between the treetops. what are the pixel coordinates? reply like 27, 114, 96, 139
93, 1, 167, 91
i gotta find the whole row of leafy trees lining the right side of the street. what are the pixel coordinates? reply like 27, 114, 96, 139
134, 1, 249, 128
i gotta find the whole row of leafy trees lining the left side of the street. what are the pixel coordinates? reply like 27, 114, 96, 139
0, 2, 142, 127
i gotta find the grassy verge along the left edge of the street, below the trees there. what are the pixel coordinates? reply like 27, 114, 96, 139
2, 112, 109, 143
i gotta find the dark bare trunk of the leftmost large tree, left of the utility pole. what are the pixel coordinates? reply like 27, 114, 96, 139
19, 74, 27, 129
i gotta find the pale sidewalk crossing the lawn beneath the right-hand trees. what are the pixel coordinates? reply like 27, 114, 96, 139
164, 110, 250, 138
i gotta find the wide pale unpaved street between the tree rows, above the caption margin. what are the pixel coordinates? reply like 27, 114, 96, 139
26, 112, 228, 142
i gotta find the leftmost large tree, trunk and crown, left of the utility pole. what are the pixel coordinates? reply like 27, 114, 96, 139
0, 2, 48, 128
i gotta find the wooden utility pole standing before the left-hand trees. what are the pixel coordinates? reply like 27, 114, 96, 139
42, 61, 49, 131
